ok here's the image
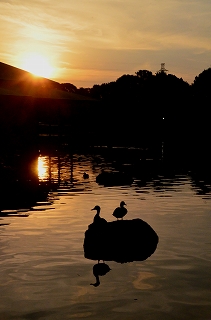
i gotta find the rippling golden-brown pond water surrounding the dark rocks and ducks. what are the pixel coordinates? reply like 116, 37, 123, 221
0, 151, 211, 320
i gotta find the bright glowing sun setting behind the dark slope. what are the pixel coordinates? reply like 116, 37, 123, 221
23, 53, 53, 78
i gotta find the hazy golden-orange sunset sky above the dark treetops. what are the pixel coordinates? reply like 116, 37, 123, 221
0, 0, 211, 87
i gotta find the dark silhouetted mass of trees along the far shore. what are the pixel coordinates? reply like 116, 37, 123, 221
61, 68, 211, 144
